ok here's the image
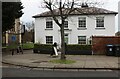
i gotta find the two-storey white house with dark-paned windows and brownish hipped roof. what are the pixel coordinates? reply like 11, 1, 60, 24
33, 7, 117, 44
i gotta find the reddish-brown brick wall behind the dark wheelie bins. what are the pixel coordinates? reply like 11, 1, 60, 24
92, 36, 120, 54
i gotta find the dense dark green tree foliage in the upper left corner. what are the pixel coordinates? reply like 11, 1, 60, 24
2, 2, 23, 32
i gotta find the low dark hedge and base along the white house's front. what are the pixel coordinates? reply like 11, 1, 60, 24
33, 44, 92, 55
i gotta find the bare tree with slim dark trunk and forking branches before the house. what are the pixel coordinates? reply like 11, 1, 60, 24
44, 0, 74, 60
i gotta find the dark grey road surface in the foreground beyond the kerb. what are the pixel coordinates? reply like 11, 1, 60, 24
2, 68, 119, 79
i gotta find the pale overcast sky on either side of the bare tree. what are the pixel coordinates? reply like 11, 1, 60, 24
20, 0, 120, 31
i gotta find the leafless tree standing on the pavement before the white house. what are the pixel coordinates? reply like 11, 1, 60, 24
44, 0, 102, 60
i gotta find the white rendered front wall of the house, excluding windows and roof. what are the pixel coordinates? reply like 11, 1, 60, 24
35, 15, 115, 44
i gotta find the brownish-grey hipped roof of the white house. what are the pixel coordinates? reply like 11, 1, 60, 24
33, 7, 118, 18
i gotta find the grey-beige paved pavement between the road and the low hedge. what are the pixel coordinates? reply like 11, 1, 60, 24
2, 50, 119, 71
